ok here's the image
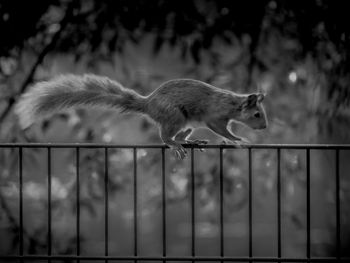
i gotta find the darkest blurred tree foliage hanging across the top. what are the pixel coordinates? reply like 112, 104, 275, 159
0, 0, 350, 131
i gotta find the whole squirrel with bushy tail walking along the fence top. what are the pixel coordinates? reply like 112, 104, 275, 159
15, 74, 267, 159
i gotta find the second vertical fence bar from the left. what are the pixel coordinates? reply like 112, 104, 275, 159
47, 147, 52, 262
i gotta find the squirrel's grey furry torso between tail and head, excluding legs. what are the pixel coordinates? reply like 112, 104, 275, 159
147, 79, 239, 123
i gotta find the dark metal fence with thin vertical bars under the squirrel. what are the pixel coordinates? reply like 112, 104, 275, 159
0, 143, 350, 262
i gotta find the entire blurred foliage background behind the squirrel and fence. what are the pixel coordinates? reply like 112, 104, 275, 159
0, 0, 350, 257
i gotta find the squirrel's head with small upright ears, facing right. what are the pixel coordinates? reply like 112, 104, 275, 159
236, 93, 267, 129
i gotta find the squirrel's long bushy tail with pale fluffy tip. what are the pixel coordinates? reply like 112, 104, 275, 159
15, 74, 144, 128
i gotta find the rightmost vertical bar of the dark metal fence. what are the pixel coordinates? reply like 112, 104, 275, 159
335, 149, 341, 261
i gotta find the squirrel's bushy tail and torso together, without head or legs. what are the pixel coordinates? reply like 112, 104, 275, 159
15, 74, 246, 131
